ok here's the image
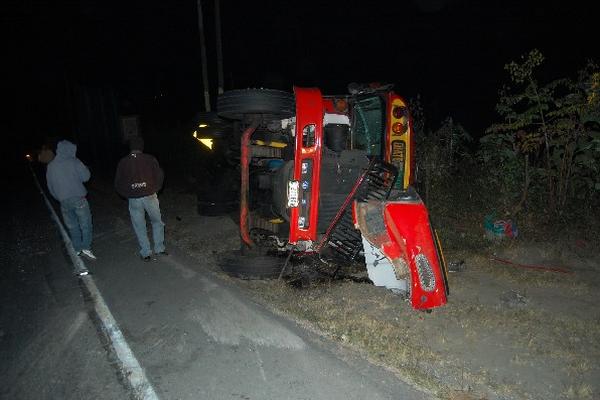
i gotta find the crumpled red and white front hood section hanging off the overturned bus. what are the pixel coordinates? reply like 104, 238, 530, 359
353, 197, 448, 309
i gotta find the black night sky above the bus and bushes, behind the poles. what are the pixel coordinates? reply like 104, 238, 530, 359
0, 0, 600, 153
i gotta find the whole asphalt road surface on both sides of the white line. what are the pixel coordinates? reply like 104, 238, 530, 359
0, 161, 429, 400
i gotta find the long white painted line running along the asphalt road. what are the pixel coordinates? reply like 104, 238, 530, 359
29, 166, 158, 400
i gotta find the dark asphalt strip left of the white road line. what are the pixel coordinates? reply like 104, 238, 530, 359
0, 165, 128, 400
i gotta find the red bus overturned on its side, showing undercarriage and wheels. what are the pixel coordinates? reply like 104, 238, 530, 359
218, 85, 448, 310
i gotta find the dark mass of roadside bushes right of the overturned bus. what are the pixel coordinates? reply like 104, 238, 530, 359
410, 54, 600, 245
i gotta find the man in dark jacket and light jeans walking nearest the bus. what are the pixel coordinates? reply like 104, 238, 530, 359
115, 136, 167, 261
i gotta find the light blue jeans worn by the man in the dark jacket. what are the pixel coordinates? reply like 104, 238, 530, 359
129, 193, 165, 257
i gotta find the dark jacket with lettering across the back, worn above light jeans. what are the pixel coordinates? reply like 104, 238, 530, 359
115, 151, 164, 198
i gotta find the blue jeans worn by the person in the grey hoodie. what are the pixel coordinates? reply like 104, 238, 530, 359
60, 197, 92, 253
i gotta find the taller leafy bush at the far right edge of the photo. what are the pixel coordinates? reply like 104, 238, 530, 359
478, 50, 600, 222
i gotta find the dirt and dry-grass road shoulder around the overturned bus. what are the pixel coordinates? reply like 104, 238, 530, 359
161, 185, 600, 400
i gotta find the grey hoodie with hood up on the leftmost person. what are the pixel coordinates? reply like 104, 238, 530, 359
46, 140, 90, 201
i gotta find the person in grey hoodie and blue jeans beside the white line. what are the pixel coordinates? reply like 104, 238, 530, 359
46, 140, 96, 260
